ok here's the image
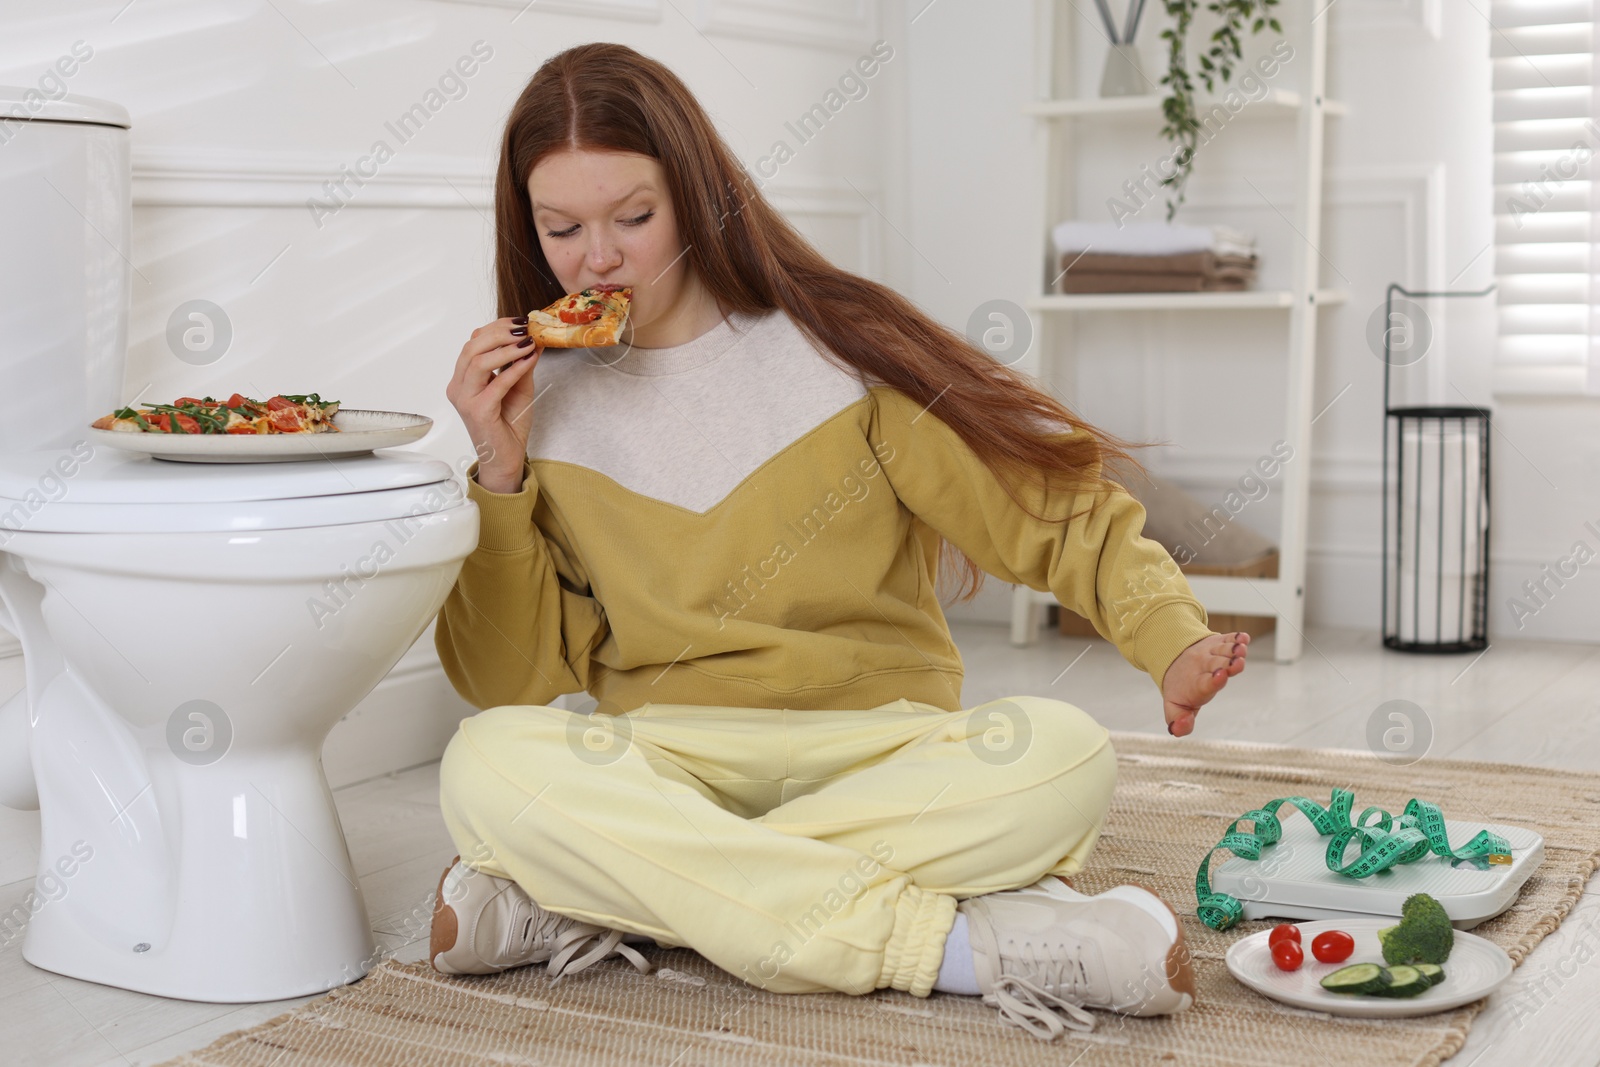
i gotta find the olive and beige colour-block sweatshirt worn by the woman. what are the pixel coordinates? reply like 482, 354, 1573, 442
435, 309, 1211, 713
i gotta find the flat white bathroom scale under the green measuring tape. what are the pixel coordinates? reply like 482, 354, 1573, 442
1211, 817, 1544, 929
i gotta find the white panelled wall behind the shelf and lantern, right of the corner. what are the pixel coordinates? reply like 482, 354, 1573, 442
909, 0, 1600, 641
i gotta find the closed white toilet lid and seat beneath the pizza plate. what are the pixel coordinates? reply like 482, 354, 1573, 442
0, 442, 464, 533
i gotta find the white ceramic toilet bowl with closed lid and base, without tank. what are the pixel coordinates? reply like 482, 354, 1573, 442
0, 443, 478, 1001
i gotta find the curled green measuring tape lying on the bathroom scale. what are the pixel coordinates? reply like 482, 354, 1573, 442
1195, 789, 1510, 929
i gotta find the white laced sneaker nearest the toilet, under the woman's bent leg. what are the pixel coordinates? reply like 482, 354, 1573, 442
427, 856, 650, 977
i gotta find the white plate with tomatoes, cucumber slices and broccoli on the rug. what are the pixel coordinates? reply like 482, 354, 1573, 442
1227, 893, 1512, 1019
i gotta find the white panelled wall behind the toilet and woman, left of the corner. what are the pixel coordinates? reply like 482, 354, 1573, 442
0, 0, 909, 784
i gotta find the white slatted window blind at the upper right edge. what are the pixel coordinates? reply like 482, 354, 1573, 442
1490, 0, 1600, 395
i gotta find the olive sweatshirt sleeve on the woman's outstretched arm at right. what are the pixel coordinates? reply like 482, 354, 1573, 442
867, 386, 1213, 689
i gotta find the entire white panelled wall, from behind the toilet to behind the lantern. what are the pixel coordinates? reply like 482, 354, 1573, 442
0, 0, 1600, 809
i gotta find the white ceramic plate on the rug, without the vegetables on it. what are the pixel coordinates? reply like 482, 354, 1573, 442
1227, 918, 1512, 1019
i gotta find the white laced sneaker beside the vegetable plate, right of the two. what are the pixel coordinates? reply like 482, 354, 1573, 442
958, 875, 1195, 1040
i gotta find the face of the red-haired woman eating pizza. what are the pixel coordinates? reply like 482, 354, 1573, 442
528, 149, 693, 328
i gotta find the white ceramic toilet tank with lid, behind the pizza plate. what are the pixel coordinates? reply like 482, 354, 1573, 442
0, 86, 133, 453
